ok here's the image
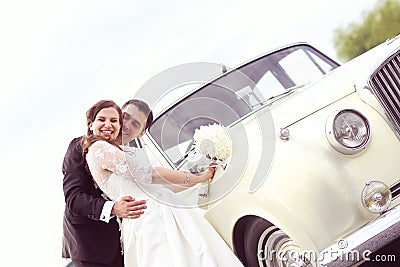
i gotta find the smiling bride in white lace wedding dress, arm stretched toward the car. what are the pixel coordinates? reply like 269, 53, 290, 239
83, 101, 242, 267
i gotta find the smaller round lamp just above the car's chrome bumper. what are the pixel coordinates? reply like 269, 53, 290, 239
361, 181, 392, 213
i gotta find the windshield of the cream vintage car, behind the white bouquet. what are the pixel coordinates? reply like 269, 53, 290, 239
149, 45, 339, 167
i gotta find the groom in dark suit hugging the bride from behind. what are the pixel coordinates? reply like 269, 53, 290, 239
62, 99, 153, 267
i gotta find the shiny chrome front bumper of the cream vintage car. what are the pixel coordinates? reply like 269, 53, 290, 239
318, 205, 400, 267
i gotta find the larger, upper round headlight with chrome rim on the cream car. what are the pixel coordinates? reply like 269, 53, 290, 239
325, 109, 371, 154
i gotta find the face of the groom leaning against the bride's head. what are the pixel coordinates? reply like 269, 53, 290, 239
122, 104, 147, 144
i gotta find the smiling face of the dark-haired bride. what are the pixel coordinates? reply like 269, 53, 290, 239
89, 108, 121, 140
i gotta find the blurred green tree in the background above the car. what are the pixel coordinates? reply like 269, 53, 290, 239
333, 0, 400, 62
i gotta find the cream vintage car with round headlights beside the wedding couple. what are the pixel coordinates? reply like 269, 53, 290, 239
138, 36, 400, 266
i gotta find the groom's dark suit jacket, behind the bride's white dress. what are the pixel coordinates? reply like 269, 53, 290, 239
62, 137, 121, 264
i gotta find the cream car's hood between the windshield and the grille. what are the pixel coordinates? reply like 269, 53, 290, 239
270, 36, 400, 128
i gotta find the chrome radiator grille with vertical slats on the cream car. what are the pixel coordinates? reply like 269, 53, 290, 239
370, 51, 400, 134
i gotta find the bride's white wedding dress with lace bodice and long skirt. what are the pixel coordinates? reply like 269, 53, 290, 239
86, 141, 242, 267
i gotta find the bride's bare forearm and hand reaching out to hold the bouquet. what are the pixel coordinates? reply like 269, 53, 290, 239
152, 167, 215, 187
